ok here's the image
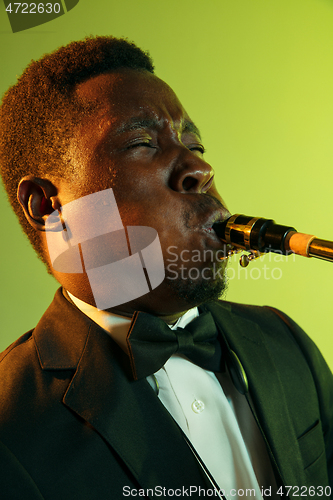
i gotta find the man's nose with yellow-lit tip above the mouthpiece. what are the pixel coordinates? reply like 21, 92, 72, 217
170, 150, 214, 193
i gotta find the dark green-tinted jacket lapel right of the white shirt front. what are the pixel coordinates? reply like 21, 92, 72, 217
205, 303, 306, 485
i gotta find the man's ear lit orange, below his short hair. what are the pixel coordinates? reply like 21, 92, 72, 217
17, 175, 61, 231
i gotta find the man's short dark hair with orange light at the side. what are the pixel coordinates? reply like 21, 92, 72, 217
0, 36, 154, 264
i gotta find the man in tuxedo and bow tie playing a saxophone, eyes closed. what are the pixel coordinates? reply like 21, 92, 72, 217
0, 37, 333, 500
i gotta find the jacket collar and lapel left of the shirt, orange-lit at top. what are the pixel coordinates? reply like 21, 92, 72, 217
34, 291, 211, 489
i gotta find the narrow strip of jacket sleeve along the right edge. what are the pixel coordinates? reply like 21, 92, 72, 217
269, 307, 333, 486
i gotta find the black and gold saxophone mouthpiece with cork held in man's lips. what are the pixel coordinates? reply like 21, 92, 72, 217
213, 214, 333, 267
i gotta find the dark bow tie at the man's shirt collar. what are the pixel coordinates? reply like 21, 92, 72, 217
126, 312, 222, 380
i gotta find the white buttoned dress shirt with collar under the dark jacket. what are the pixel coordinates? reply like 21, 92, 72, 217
67, 292, 276, 499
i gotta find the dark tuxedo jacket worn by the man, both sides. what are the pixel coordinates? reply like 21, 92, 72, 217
0, 290, 333, 500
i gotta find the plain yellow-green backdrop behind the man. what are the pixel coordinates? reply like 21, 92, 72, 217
0, 0, 333, 367
